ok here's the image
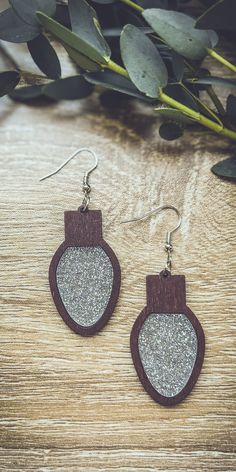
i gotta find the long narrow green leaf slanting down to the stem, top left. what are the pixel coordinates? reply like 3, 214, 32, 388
37, 12, 108, 64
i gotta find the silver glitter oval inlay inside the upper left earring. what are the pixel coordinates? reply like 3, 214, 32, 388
56, 247, 113, 327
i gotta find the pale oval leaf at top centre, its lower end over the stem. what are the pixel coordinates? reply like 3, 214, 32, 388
120, 25, 168, 98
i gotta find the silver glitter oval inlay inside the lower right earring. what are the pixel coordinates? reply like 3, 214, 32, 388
138, 313, 198, 397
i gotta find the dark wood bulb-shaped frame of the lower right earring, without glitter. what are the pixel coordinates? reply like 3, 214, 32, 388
130, 272, 205, 406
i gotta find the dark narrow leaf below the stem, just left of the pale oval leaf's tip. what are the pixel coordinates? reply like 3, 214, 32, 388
84, 70, 152, 101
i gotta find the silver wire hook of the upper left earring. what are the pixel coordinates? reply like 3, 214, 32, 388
40, 148, 98, 211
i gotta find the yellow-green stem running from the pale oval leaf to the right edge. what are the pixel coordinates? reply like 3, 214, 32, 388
159, 91, 236, 140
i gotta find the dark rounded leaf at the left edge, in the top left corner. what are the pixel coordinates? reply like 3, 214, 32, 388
0, 8, 40, 43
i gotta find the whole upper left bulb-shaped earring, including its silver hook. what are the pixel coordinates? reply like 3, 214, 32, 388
40, 148, 121, 336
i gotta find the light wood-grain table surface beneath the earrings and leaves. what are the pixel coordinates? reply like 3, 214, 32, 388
0, 41, 236, 472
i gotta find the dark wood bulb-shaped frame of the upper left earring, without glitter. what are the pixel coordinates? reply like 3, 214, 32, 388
49, 210, 121, 336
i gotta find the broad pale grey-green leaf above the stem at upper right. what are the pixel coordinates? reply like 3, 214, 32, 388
142, 8, 216, 60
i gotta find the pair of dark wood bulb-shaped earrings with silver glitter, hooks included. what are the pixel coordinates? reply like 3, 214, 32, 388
41, 148, 205, 406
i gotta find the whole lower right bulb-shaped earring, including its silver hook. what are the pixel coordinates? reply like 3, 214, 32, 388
123, 205, 205, 406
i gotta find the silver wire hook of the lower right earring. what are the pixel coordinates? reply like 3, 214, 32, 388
121, 205, 182, 275
